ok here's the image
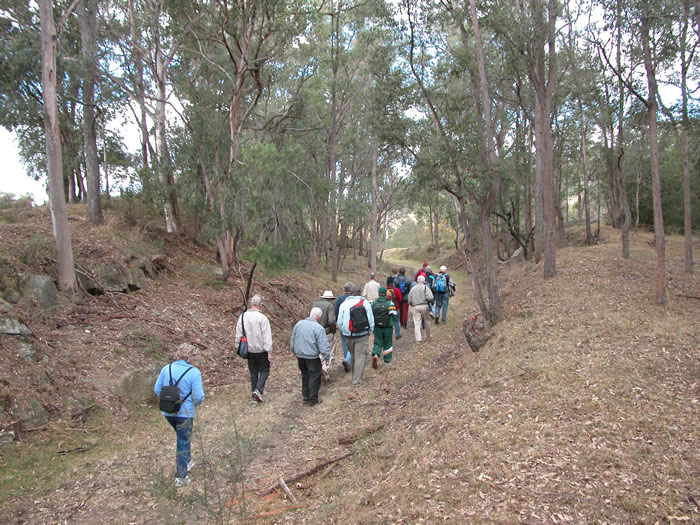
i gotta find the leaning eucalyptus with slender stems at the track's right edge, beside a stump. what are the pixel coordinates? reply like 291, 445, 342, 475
402, 1, 507, 322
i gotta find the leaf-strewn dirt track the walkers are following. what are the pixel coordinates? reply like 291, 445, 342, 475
2, 261, 465, 524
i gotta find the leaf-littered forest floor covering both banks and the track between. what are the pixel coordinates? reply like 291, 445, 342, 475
0, 204, 700, 524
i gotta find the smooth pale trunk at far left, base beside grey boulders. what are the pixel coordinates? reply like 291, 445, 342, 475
39, 0, 76, 294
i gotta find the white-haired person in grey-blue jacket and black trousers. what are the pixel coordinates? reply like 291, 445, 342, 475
289, 307, 331, 406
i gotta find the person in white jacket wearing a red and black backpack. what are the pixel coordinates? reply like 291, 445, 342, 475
338, 286, 374, 386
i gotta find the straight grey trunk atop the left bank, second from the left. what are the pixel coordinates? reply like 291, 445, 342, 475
77, 0, 103, 224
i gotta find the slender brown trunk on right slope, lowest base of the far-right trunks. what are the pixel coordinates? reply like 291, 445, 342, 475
642, 13, 667, 304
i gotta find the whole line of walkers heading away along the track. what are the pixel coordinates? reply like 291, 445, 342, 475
154, 263, 455, 487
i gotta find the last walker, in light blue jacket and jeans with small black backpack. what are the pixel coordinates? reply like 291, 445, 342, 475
153, 343, 204, 488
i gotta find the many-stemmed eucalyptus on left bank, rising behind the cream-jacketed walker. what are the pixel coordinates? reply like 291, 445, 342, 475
165, 1, 313, 279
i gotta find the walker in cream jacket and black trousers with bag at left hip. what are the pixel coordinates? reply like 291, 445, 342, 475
233, 294, 272, 403
